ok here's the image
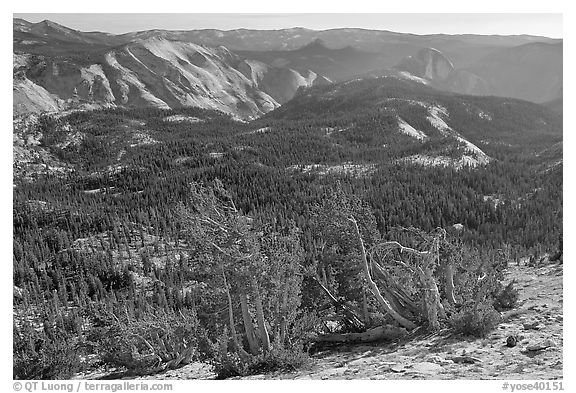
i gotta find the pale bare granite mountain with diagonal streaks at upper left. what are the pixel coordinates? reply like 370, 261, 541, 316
14, 38, 323, 118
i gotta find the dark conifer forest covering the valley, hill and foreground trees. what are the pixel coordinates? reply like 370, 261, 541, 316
13, 78, 562, 379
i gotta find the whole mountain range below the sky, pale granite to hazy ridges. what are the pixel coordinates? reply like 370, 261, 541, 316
13, 19, 562, 119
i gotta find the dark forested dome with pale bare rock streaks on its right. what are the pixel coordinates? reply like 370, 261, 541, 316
262, 75, 562, 169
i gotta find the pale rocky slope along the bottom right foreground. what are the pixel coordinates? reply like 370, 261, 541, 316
132, 258, 563, 380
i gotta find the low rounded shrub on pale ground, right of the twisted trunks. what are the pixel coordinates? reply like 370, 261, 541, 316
449, 300, 501, 337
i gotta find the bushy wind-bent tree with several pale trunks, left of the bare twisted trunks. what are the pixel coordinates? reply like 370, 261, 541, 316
178, 180, 303, 359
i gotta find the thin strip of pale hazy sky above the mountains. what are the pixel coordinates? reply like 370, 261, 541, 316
14, 13, 563, 38
